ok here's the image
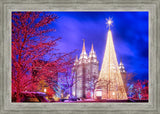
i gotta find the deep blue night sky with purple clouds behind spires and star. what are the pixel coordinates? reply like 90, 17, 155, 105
51, 12, 149, 80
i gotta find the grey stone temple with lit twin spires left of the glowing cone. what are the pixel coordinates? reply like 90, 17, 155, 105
72, 40, 99, 98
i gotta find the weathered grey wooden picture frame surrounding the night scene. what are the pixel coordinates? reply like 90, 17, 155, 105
0, 0, 160, 114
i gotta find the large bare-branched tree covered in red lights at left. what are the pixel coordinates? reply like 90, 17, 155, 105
12, 12, 75, 102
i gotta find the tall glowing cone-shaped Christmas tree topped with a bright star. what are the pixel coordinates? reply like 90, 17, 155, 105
96, 19, 127, 100
